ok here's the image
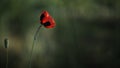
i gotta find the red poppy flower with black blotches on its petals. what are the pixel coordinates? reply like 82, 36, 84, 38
40, 11, 56, 28
